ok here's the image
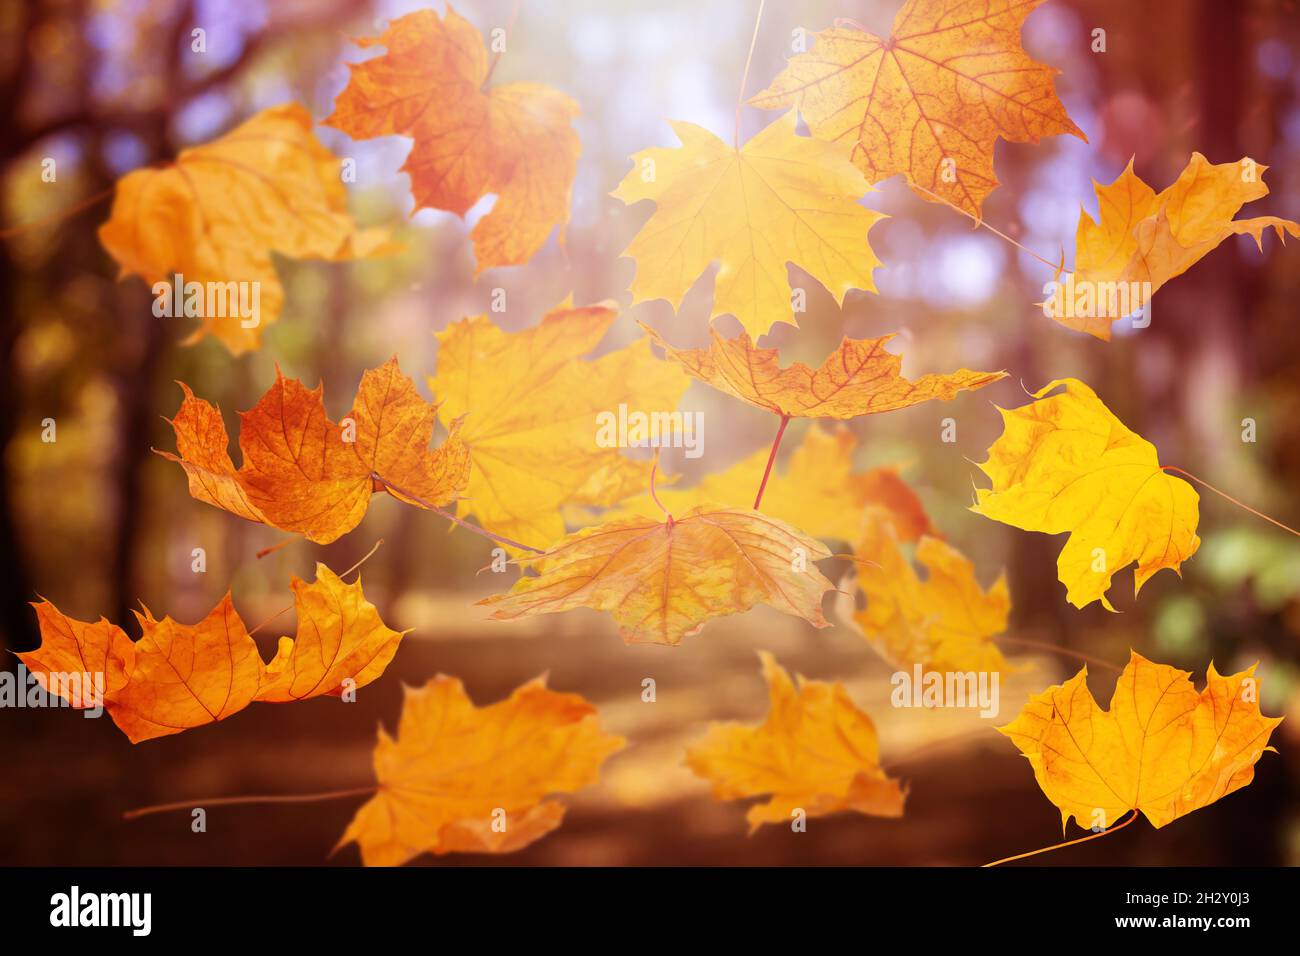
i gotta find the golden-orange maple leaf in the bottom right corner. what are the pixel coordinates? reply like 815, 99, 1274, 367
998, 652, 1282, 830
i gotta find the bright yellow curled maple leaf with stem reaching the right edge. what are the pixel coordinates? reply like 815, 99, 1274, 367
971, 378, 1201, 610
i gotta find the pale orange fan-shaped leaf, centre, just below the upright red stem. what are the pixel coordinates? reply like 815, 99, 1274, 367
478, 507, 833, 644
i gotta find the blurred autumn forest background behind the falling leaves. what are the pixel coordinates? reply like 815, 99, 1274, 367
0, 0, 1300, 865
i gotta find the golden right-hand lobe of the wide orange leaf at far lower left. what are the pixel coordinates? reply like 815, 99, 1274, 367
257, 564, 407, 702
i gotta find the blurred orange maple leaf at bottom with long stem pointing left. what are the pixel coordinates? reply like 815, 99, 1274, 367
338, 675, 624, 866
